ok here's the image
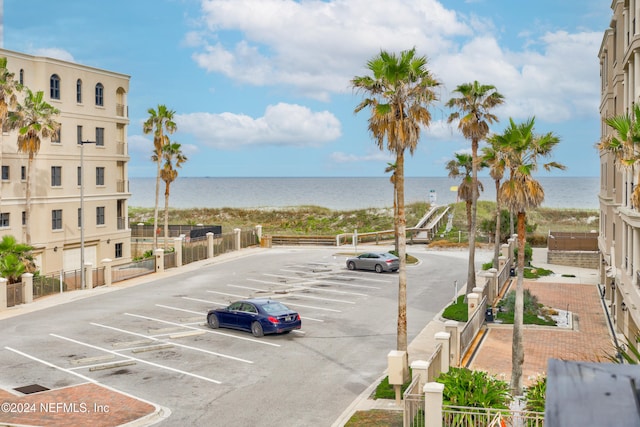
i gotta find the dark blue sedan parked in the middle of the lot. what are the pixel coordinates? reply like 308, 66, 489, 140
207, 298, 302, 337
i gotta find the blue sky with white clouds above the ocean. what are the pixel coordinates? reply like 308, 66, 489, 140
0, 0, 611, 177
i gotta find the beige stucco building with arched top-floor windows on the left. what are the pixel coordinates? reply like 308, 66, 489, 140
0, 49, 131, 274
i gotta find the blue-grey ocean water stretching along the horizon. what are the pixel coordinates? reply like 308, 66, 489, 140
129, 177, 600, 210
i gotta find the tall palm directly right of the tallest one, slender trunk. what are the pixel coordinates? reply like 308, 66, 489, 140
446, 81, 504, 295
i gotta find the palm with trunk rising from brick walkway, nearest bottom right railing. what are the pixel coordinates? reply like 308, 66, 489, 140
499, 118, 565, 396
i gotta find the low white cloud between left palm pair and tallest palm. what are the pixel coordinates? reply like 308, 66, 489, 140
175, 103, 342, 149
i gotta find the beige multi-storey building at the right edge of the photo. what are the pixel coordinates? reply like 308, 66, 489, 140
598, 0, 640, 350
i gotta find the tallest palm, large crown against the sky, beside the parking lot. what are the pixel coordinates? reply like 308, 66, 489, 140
351, 48, 440, 360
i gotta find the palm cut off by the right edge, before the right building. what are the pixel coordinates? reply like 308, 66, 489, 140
597, 104, 640, 209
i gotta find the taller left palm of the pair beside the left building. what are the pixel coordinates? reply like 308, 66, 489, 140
142, 105, 177, 249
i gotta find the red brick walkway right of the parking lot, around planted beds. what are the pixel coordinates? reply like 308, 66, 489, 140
469, 281, 613, 385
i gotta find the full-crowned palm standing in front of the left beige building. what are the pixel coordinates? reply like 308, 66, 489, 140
9, 89, 60, 245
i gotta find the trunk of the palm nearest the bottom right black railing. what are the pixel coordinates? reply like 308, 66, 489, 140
511, 212, 526, 396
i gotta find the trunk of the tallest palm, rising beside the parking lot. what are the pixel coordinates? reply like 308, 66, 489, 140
396, 151, 409, 380
